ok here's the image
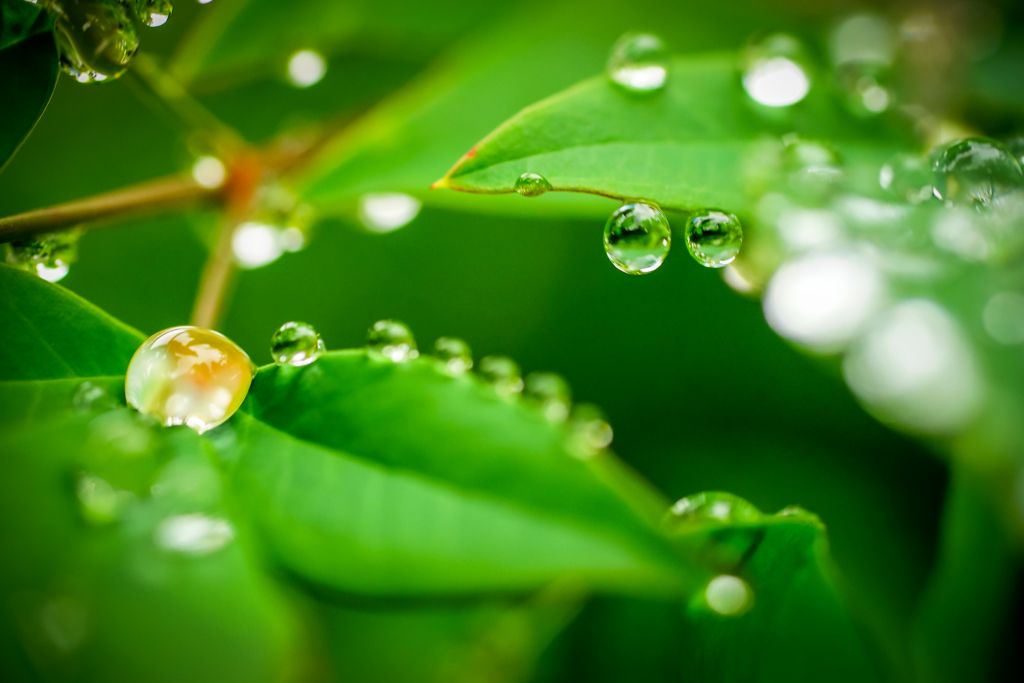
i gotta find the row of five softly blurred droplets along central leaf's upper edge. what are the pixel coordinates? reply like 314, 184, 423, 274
367, 319, 612, 458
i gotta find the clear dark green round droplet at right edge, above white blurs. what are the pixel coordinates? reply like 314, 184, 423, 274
934, 137, 1024, 209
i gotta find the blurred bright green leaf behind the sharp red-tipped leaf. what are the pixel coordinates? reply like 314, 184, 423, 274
296, 0, 820, 215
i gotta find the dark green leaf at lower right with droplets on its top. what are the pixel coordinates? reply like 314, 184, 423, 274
680, 501, 885, 683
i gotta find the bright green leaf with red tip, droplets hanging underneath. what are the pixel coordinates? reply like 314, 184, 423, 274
436, 54, 905, 212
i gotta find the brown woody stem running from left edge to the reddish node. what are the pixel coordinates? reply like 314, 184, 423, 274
0, 175, 222, 243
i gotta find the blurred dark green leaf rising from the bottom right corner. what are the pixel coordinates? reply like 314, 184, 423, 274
913, 464, 1017, 683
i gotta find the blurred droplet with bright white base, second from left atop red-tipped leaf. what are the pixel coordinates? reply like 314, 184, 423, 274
743, 34, 811, 108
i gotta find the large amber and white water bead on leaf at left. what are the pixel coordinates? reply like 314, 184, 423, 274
125, 326, 253, 433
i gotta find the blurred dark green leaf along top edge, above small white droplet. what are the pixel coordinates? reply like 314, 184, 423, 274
173, 0, 494, 81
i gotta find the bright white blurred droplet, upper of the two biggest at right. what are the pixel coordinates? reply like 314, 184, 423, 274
764, 251, 885, 353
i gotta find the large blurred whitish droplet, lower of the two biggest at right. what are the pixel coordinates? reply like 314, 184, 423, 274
843, 299, 984, 434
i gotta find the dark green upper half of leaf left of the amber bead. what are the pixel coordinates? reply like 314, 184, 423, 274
0, 265, 142, 381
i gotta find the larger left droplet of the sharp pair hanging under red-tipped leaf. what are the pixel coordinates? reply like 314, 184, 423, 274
604, 204, 672, 275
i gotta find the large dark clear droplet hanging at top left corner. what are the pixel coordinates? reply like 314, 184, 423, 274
49, 0, 138, 83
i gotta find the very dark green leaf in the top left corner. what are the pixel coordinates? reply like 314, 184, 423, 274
0, 0, 57, 171
